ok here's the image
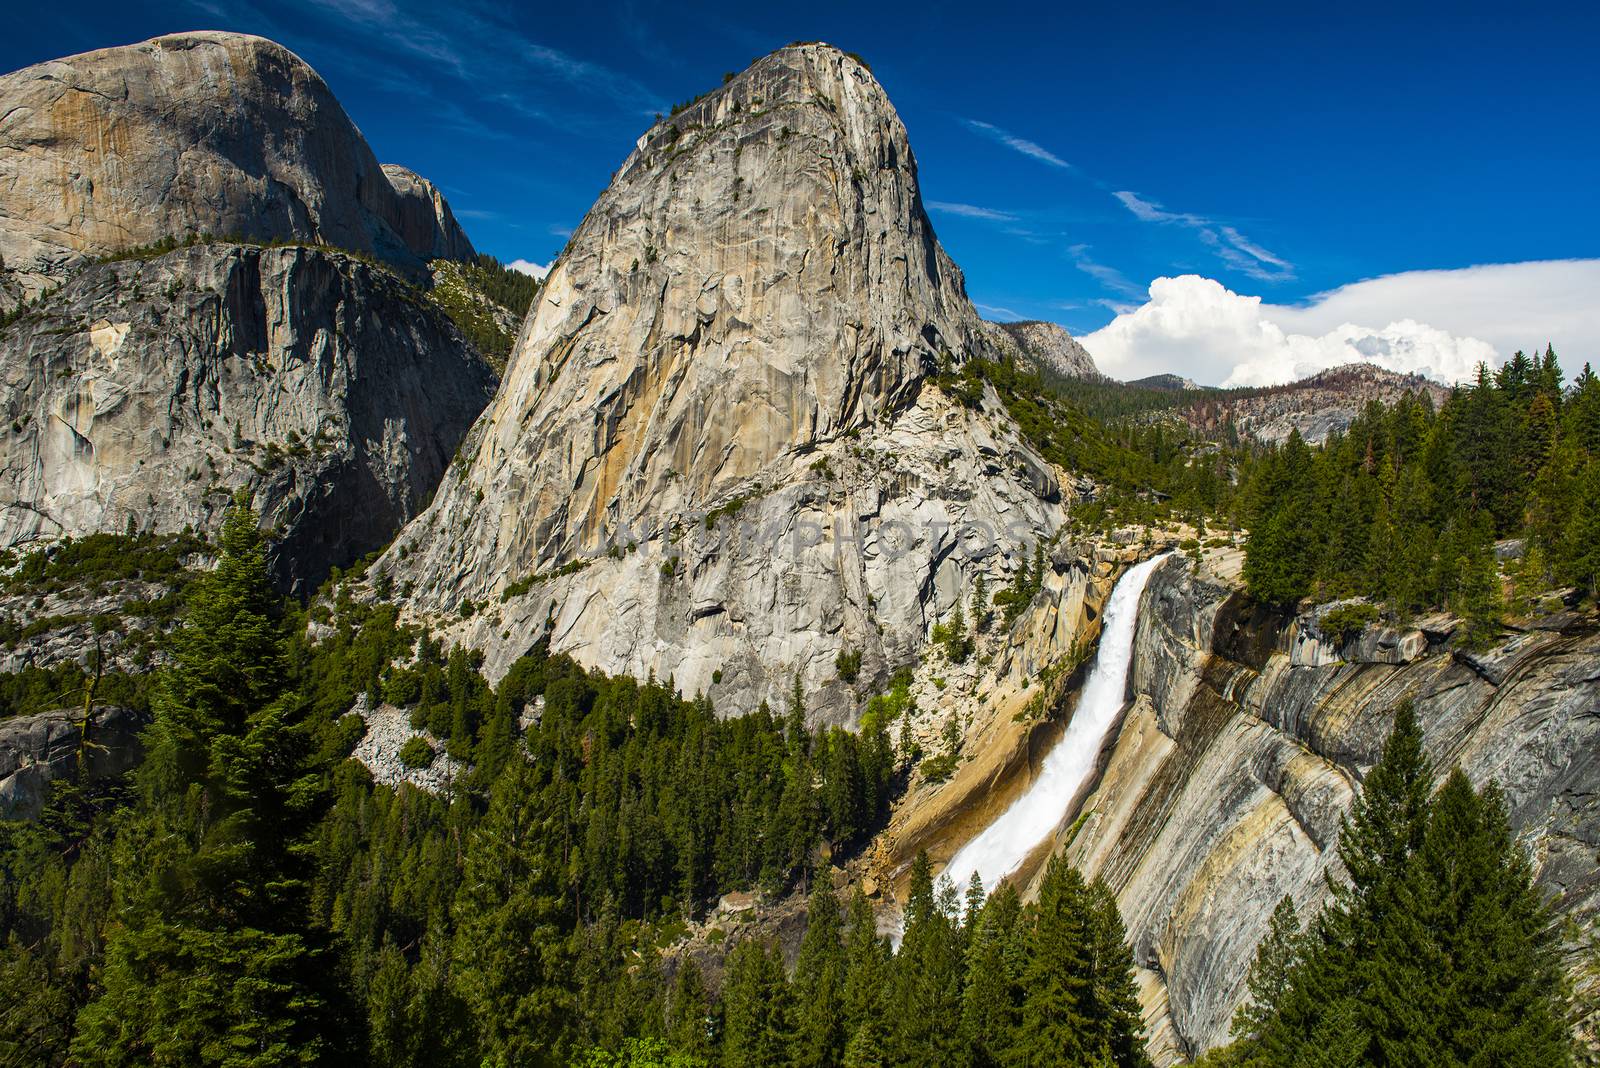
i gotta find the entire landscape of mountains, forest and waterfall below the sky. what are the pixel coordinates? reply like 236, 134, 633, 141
0, 22, 1600, 1068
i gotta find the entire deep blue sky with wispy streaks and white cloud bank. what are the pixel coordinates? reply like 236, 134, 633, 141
0, 0, 1600, 381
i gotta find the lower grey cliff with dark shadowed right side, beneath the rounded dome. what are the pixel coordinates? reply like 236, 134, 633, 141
0, 245, 494, 590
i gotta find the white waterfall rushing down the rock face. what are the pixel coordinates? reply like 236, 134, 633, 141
944, 556, 1165, 891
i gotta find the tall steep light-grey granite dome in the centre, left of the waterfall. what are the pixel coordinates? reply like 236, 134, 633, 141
378, 45, 1064, 718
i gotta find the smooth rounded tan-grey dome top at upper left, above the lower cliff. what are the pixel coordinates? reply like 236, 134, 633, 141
0, 32, 472, 303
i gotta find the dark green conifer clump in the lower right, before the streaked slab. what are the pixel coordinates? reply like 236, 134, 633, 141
1235, 707, 1573, 1068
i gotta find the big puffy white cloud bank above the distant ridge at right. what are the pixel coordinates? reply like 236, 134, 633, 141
1080, 259, 1600, 385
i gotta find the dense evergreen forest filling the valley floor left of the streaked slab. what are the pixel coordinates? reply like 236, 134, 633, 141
0, 504, 1144, 1065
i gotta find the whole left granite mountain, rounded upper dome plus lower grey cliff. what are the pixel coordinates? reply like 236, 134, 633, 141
0, 34, 494, 592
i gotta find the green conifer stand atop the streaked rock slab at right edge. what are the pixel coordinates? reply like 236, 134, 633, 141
1240, 350, 1600, 617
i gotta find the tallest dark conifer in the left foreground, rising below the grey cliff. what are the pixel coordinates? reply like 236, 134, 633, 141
74, 496, 339, 1065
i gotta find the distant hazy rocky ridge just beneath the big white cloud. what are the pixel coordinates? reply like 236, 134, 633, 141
1182, 363, 1450, 444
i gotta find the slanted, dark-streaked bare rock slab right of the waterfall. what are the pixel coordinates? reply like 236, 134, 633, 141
1058, 558, 1600, 1063
